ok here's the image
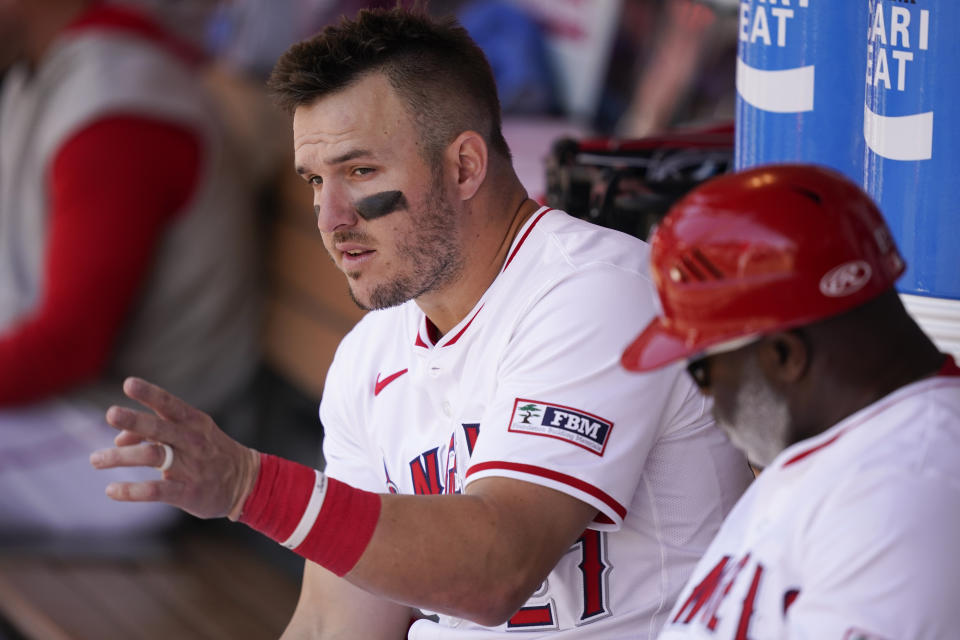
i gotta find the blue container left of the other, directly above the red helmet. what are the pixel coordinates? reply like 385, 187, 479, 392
734, 0, 872, 184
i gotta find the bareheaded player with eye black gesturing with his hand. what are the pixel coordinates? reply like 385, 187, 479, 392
93, 10, 751, 639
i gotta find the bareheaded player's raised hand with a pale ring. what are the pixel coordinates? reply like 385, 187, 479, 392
90, 378, 260, 519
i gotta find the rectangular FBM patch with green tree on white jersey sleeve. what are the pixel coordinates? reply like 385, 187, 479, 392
507, 398, 613, 456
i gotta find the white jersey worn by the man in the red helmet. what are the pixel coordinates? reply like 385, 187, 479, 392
660, 360, 960, 640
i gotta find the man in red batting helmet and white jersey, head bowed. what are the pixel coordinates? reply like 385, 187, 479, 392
623, 165, 960, 640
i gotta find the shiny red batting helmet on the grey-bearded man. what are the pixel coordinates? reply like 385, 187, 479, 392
622, 165, 905, 371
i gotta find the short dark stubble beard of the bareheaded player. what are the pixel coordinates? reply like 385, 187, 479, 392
350, 181, 463, 310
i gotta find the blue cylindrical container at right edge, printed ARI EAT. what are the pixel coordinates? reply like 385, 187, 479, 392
863, 0, 960, 299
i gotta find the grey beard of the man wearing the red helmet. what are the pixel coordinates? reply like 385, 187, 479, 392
718, 359, 790, 467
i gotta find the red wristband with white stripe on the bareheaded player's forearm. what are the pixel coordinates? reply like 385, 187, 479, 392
239, 453, 380, 576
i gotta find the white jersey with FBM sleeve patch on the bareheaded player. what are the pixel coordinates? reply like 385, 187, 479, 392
320, 209, 752, 640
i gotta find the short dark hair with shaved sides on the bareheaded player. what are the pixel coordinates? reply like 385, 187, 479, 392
268, 8, 510, 159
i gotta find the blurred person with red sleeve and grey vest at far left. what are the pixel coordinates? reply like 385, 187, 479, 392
0, 0, 259, 536
